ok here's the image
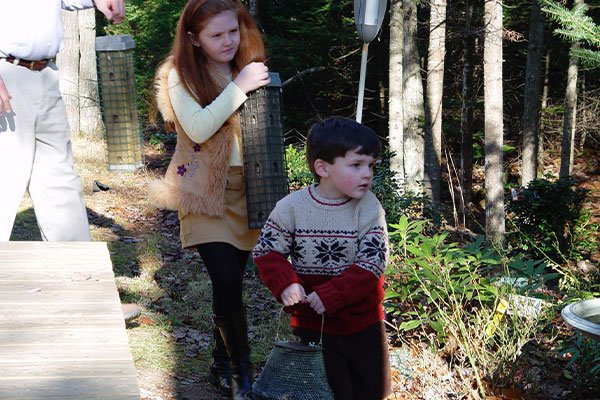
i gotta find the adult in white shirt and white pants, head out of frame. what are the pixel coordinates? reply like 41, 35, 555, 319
0, 0, 125, 241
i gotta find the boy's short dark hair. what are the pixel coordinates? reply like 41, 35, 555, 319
306, 117, 381, 182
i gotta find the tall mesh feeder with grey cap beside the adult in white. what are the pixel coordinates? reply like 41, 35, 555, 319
96, 35, 144, 171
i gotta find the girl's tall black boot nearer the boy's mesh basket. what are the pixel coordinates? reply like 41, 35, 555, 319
214, 311, 253, 400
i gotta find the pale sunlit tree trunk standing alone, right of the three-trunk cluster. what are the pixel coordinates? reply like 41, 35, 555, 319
483, 0, 505, 246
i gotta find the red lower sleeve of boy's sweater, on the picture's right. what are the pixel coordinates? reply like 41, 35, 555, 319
313, 264, 383, 315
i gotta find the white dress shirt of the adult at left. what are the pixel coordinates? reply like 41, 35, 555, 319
0, 0, 93, 61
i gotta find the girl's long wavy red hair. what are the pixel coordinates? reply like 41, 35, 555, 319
162, 0, 266, 107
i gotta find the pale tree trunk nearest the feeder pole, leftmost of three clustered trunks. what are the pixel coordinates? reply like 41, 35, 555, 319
388, 0, 405, 190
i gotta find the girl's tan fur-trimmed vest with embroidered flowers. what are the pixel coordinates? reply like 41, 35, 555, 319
148, 60, 241, 217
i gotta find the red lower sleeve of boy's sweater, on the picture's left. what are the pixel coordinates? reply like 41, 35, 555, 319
254, 251, 304, 302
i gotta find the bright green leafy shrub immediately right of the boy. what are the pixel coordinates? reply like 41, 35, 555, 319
385, 216, 501, 344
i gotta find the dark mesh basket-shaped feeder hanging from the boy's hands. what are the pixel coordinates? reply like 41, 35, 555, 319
252, 341, 333, 400
